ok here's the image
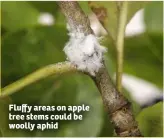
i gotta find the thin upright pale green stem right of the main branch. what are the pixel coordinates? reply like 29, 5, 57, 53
116, 1, 128, 92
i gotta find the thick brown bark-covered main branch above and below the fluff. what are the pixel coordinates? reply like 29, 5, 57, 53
58, 1, 141, 137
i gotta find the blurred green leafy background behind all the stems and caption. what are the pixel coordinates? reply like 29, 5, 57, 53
0, 1, 163, 137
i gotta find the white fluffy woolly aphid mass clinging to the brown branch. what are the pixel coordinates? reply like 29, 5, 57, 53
64, 26, 107, 76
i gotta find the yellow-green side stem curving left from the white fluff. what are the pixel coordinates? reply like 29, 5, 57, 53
0, 62, 77, 97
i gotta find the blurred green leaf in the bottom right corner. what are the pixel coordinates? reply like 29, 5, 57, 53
137, 103, 163, 137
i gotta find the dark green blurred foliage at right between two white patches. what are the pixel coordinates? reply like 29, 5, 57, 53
105, 33, 163, 88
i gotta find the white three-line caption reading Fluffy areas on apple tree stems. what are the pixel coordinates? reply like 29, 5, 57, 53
9, 104, 90, 131
